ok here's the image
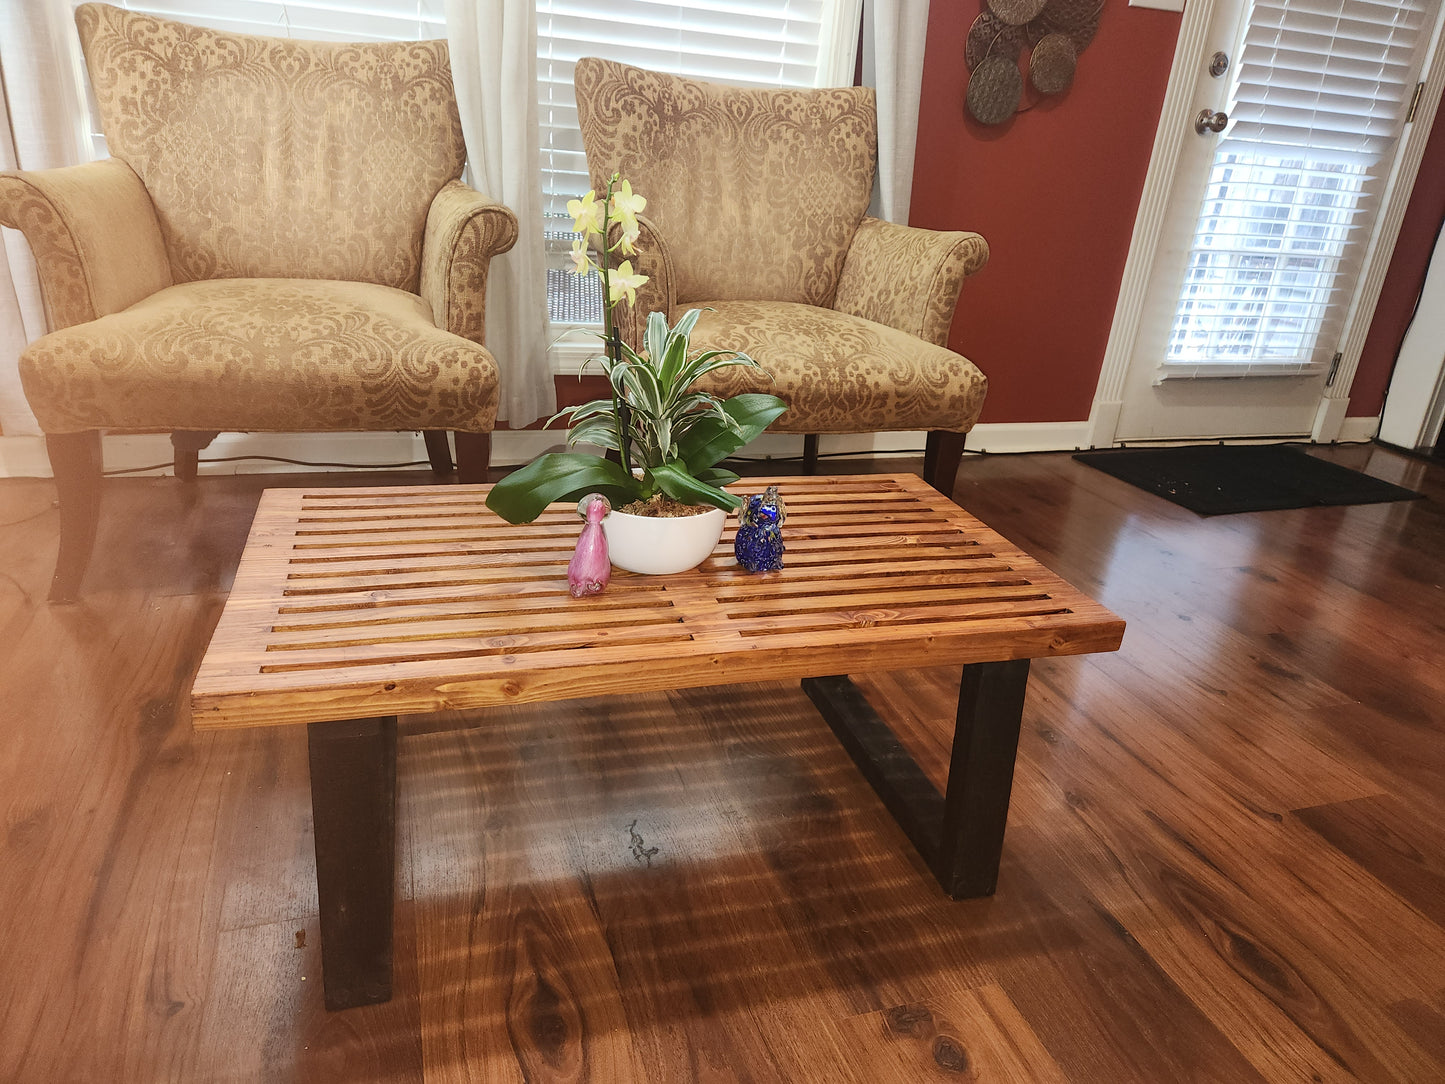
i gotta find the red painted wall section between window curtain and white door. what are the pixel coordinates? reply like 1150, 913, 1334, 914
909, 0, 1181, 422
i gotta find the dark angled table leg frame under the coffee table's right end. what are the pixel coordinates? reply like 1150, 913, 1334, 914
802, 659, 1029, 899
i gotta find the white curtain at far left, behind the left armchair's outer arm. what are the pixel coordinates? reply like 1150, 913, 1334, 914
0, 0, 88, 436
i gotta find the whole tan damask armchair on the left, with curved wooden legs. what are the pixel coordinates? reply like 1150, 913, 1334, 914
0, 4, 517, 598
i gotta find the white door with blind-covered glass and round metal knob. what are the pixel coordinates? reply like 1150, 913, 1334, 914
1101, 0, 1441, 441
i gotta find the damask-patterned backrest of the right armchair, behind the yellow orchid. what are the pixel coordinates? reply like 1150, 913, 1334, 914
574, 58, 877, 306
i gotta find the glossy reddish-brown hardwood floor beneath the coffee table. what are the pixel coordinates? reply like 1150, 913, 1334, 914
0, 447, 1445, 1084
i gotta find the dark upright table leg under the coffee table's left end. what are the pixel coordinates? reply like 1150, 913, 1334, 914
306, 715, 396, 1009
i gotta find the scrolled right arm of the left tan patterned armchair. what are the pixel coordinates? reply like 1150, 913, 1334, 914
420, 181, 517, 344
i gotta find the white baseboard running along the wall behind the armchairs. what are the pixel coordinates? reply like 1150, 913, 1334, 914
0, 418, 1380, 478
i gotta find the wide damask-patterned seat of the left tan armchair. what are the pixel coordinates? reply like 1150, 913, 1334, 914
20, 279, 497, 434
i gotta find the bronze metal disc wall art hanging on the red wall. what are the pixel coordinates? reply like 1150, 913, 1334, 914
964, 0, 1104, 124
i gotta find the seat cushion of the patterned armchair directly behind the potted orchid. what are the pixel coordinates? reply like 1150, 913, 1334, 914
672, 301, 988, 434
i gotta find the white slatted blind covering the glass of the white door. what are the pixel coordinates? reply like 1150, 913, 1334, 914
1160, 0, 1439, 379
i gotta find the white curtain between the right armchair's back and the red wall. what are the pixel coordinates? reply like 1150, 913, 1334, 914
863, 0, 930, 224
